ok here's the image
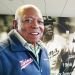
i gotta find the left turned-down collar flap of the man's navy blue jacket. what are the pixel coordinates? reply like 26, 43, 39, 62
8, 30, 26, 51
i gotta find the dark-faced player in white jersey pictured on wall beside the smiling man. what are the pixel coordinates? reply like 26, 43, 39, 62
43, 21, 65, 75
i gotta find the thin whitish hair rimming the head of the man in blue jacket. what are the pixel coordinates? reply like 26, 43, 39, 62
15, 4, 42, 20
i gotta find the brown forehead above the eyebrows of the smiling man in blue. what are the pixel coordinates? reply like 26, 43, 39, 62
20, 7, 43, 19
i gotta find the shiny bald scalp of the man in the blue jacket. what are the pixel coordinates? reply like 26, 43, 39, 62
15, 4, 42, 20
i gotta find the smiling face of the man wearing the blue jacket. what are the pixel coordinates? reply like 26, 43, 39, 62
14, 5, 44, 44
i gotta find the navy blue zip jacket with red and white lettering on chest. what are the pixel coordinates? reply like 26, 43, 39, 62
0, 32, 50, 75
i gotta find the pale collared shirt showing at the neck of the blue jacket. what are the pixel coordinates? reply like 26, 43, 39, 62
14, 29, 43, 63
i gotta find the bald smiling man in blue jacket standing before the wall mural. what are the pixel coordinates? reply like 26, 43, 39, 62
0, 5, 50, 75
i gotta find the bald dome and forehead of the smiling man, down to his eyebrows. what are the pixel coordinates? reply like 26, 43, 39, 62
15, 6, 43, 19
